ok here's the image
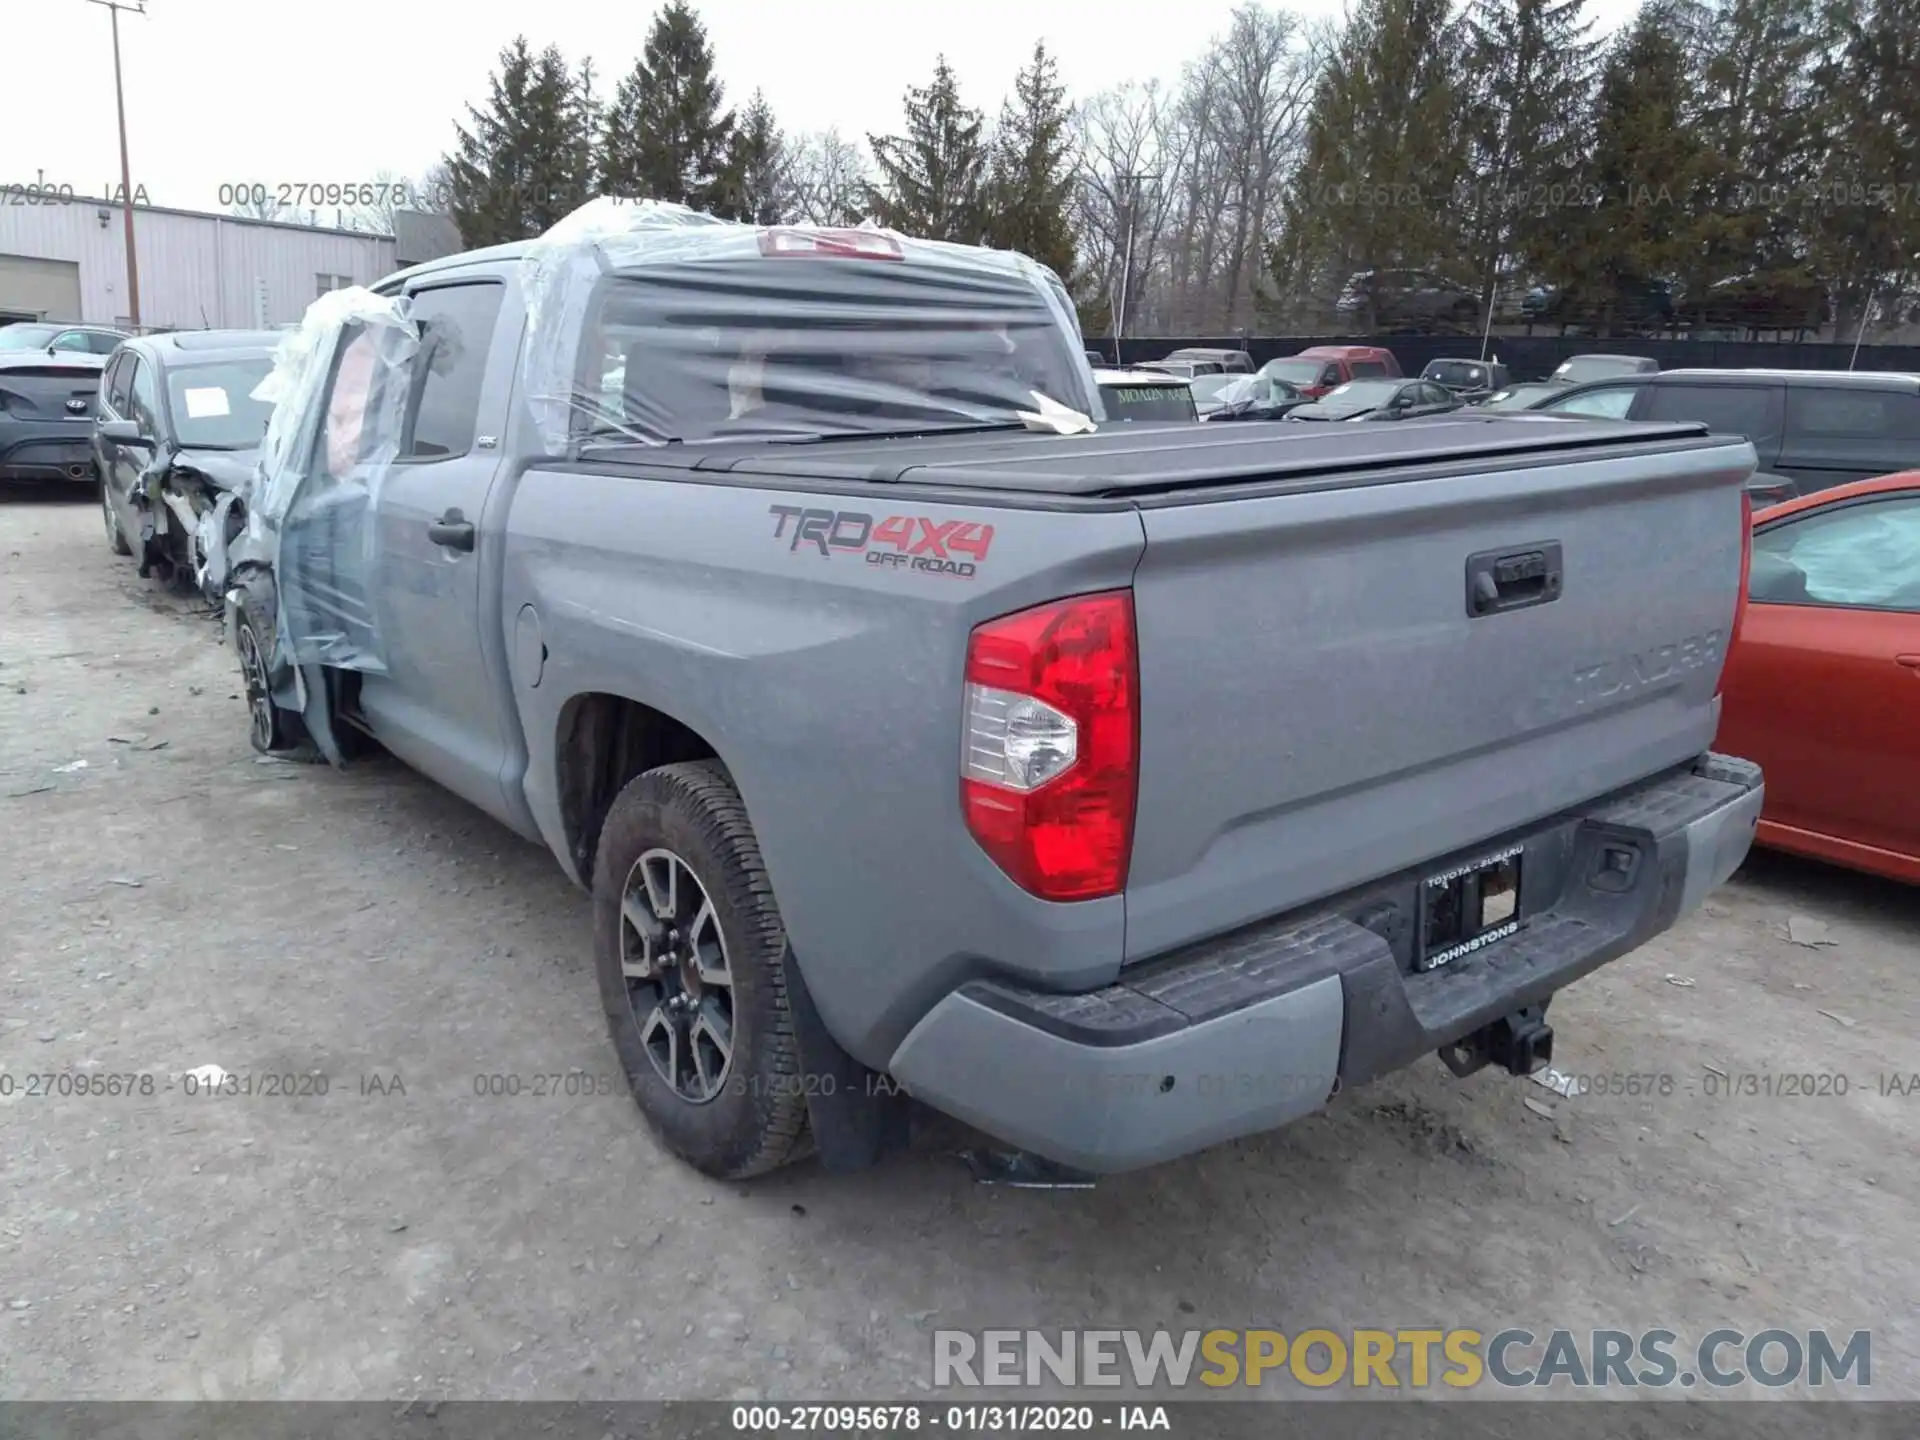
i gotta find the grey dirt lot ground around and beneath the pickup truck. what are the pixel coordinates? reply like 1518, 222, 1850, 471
0, 492, 1920, 1400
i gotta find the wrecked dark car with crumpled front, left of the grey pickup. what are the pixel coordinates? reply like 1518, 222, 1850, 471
92, 330, 280, 578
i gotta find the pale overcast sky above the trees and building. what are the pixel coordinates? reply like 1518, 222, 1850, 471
11, 0, 1634, 222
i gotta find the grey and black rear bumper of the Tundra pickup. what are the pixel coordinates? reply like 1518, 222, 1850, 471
889, 755, 1763, 1173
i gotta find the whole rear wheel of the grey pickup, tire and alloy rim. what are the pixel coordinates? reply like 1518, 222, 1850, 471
593, 760, 808, 1179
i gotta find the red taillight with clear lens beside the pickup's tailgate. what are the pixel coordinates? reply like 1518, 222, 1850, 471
960, 589, 1140, 900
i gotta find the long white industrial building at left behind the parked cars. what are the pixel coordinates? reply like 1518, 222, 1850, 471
0, 194, 461, 330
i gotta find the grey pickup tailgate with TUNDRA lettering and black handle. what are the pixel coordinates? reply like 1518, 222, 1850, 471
1127, 440, 1753, 960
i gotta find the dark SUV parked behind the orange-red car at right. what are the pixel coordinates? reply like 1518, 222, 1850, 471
1505, 371, 1920, 499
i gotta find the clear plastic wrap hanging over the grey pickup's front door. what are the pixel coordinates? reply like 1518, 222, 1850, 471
238, 286, 420, 672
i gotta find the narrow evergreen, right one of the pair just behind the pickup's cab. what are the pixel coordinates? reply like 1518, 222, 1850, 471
983, 40, 1073, 286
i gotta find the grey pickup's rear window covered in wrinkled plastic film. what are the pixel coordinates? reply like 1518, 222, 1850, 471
572, 257, 1094, 444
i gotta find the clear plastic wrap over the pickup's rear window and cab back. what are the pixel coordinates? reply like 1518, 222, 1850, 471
520, 198, 1102, 453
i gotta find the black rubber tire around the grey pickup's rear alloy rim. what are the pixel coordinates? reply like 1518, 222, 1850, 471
593, 760, 808, 1179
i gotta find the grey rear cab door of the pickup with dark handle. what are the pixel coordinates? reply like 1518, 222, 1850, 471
359, 276, 518, 829
